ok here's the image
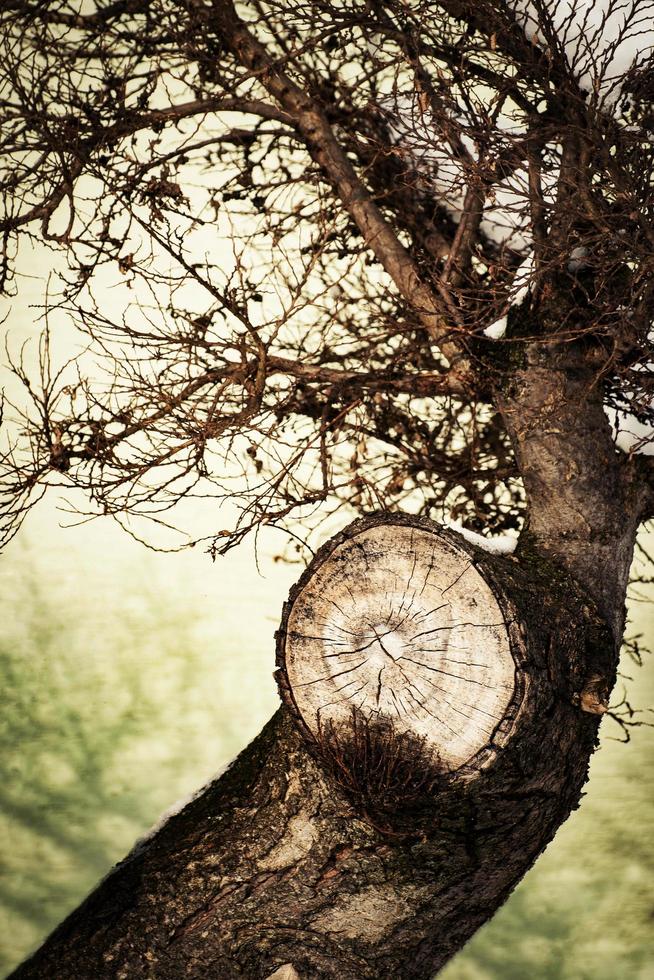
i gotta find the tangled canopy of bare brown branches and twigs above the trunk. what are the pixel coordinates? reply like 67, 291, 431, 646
0, 0, 654, 552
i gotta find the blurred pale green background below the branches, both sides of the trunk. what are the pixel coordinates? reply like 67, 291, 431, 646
0, 505, 654, 980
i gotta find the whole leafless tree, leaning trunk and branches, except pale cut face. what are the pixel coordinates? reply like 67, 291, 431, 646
2, 0, 654, 978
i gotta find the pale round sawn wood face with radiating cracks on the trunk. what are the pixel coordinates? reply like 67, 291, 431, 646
279, 522, 516, 770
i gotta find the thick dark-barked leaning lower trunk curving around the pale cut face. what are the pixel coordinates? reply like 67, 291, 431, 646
7, 516, 616, 980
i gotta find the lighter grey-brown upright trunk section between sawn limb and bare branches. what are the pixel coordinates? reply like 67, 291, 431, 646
496, 336, 649, 644
